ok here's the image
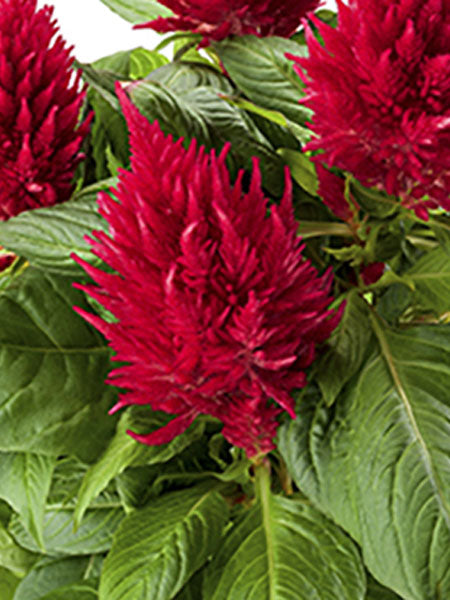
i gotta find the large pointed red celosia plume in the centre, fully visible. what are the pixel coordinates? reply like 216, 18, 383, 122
72, 85, 339, 455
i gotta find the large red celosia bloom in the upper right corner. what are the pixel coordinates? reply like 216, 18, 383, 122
291, 0, 450, 219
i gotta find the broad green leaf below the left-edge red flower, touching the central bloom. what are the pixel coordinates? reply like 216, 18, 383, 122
0, 193, 106, 277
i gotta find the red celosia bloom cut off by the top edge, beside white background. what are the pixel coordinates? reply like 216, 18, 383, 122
137, 0, 320, 45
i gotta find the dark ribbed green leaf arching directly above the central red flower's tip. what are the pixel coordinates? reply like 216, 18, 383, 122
130, 81, 284, 196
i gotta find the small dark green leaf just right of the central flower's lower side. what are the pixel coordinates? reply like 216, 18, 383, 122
315, 291, 372, 405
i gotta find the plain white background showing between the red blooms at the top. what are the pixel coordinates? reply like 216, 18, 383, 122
38, 0, 336, 62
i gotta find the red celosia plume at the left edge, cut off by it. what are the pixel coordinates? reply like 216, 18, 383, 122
0, 0, 88, 221
